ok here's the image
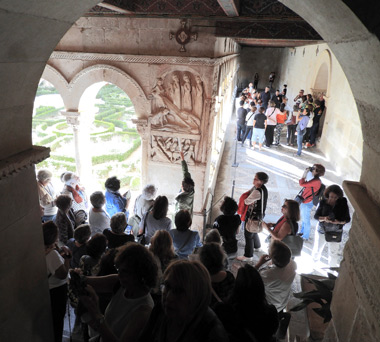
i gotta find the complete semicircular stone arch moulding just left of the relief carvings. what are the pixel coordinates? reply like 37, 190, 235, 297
67, 64, 150, 118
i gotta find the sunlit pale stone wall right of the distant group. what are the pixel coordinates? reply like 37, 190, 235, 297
279, 44, 363, 180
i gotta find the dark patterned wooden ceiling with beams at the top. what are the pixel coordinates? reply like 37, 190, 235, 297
87, 0, 322, 47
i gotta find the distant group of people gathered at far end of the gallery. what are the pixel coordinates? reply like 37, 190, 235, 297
236, 80, 325, 156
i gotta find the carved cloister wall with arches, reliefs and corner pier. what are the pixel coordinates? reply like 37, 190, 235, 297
44, 18, 239, 229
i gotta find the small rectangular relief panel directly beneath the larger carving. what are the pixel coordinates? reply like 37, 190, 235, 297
150, 135, 197, 165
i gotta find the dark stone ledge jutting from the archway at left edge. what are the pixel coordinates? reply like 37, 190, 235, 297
0, 146, 50, 181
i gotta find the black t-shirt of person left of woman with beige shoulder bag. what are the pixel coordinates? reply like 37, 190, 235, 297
213, 214, 241, 254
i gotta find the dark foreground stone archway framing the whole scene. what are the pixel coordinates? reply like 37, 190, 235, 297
0, 0, 380, 341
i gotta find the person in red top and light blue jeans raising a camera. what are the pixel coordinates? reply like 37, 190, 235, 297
299, 164, 325, 241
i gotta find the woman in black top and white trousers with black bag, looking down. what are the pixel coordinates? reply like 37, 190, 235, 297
313, 184, 351, 267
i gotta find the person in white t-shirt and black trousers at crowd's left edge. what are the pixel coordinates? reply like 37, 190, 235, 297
42, 221, 71, 342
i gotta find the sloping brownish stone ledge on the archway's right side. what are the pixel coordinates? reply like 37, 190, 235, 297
343, 181, 380, 240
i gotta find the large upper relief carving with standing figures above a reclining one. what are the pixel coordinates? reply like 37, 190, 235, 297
149, 72, 204, 134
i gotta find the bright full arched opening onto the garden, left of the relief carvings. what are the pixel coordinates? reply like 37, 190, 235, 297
77, 82, 141, 191
